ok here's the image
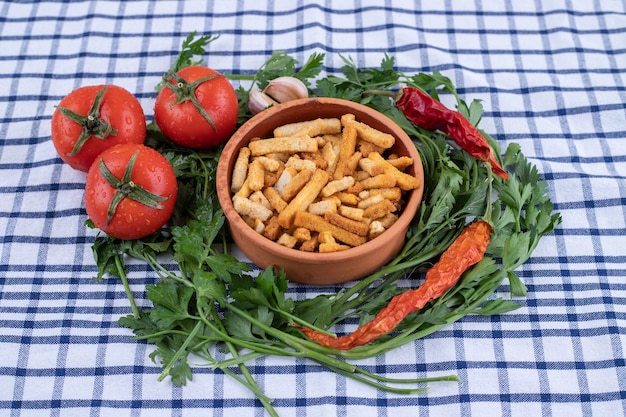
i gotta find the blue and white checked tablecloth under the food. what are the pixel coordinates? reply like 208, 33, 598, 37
0, 0, 626, 417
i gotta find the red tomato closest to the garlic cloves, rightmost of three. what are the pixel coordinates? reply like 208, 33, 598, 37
154, 66, 239, 149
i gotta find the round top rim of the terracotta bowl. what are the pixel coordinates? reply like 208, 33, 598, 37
216, 97, 424, 264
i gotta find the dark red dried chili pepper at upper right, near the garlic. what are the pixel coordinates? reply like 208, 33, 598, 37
396, 87, 509, 180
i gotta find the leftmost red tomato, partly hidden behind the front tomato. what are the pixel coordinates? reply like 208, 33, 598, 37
52, 85, 146, 172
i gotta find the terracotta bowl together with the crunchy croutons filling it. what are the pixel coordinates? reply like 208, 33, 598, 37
216, 98, 424, 285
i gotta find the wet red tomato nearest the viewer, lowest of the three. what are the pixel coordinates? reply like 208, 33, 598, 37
85, 144, 178, 239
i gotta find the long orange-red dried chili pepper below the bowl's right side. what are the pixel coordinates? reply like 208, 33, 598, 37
296, 220, 491, 350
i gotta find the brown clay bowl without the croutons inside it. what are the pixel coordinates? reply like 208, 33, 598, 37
216, 98, 424, 285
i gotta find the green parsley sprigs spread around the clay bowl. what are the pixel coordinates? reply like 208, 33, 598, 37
93, 35, 561, 415
